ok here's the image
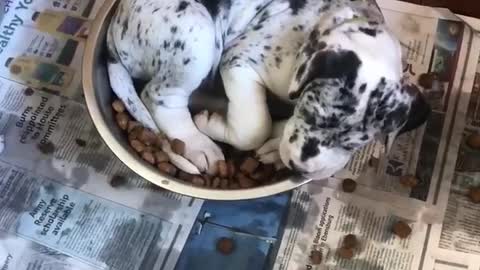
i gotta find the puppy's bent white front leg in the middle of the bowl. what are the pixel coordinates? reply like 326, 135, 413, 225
195, 61, 272, 150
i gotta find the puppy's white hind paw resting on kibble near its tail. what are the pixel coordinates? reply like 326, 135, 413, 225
179, 132, 225, 173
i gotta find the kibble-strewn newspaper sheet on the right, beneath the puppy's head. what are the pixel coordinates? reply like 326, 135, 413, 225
274, 0, 480, 270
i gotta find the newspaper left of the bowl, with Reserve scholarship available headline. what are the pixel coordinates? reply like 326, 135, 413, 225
0, 0, 203, 270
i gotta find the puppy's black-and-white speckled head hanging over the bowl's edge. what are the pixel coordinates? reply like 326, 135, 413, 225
279, 26, 430, 179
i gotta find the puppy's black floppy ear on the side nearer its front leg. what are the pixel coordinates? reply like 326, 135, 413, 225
288, 48, 362, 99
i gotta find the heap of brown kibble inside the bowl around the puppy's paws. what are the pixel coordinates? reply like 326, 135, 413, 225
112, 100, 292, 189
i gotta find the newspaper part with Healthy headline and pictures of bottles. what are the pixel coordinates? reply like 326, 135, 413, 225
0, 0, 103, 101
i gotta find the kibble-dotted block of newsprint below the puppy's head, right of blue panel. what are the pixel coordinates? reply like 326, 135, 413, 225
274, 183, 432, 270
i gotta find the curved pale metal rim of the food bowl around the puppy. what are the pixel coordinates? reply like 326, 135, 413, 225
82, 0, 309, 200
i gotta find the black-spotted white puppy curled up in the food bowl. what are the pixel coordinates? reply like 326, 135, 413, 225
107, 0, 430, 179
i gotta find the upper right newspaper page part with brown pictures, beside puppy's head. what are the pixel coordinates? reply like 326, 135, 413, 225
335, 0, 473, 204
